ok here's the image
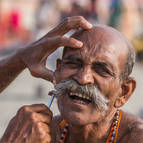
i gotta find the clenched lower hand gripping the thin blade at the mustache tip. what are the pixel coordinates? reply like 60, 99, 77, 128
0, 104, 52, 143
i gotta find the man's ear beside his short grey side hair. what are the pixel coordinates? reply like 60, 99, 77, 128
114, 77, 136, 108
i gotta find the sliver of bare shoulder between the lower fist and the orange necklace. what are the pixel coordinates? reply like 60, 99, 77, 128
51, 115, 62, 143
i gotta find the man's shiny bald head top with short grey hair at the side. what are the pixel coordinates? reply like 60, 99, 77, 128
63, 25, 135, 79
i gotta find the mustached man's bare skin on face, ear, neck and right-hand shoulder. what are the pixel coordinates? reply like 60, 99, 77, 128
53, 27, 143, 143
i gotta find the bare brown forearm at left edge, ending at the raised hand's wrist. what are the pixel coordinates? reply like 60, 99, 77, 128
0, 52, 25, 92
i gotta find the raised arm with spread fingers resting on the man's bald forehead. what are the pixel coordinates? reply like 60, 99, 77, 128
0, 16, 92, 92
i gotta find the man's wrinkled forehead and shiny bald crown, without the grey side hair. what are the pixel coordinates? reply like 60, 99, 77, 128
63, 26, 128, 78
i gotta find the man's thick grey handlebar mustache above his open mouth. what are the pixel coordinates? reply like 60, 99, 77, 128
53, 79, 108, 111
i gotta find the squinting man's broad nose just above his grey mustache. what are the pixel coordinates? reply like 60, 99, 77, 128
73, 65, 94, 84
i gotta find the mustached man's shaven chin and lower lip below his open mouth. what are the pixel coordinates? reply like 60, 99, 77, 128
57, 96, 101, 126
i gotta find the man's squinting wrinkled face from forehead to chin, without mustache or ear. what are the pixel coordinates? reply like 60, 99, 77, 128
55, 27, 126, 125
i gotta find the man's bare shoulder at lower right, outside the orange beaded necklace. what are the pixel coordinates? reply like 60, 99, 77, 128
119, 112, 143, 143
